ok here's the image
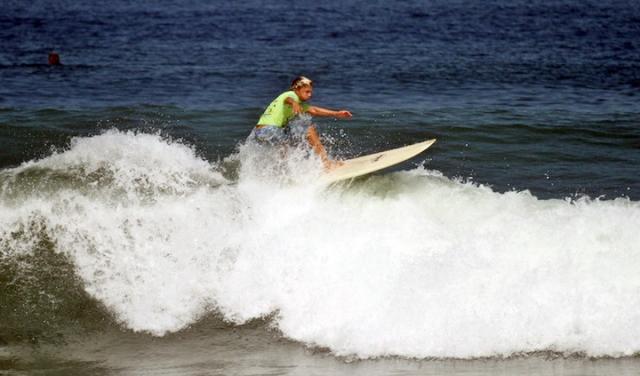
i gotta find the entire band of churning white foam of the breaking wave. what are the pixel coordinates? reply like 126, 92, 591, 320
0, 131, 640, 358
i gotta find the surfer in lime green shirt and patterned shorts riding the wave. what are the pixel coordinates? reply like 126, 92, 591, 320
249, 76, 352, 168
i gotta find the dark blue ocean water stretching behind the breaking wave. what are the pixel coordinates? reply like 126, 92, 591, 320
0, 0, 640, 199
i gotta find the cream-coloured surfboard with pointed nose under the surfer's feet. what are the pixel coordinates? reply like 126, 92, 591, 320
323, 138, 436, 183
